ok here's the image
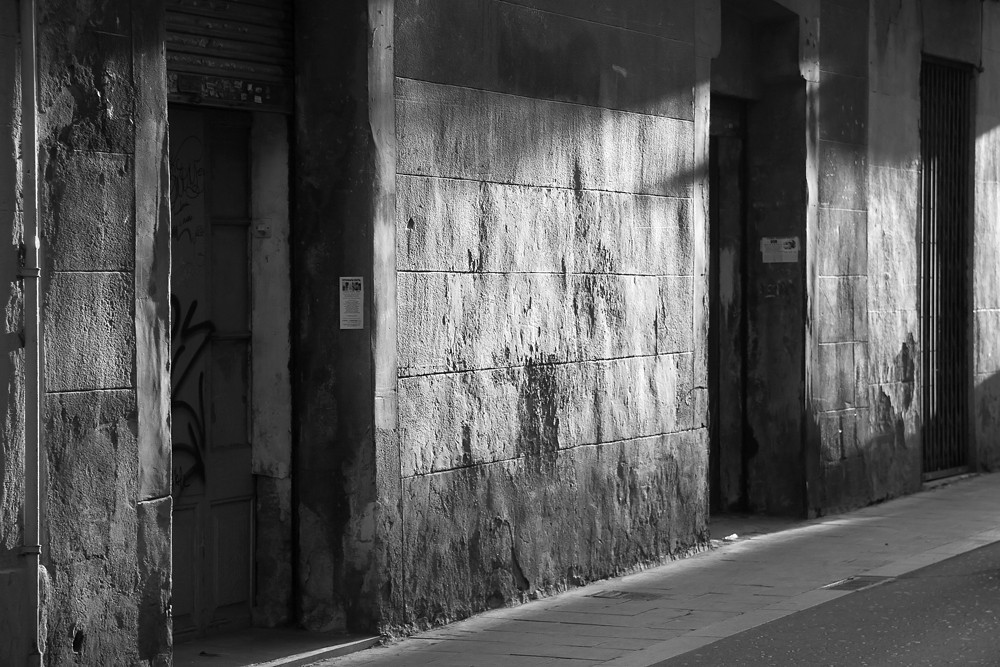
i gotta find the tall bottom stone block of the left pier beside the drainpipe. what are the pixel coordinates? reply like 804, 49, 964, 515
43, 391, 142, 664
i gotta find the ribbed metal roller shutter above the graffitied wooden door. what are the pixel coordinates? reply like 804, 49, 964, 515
166, 0, 293, 113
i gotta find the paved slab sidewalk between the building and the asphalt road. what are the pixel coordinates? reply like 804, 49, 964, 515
316, 475, 1000, 667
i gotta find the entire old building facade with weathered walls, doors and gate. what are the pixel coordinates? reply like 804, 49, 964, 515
0, 0, 1000, 665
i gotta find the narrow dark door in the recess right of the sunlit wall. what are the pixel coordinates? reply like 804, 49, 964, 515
708, 96, 747, 512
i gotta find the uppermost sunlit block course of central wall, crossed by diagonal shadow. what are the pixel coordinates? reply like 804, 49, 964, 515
396, 79, 695, 197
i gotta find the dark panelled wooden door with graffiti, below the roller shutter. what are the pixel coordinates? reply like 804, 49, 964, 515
169, 106, 254, 639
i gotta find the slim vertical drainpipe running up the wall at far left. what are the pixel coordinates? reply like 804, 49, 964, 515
20, 0, 43, 665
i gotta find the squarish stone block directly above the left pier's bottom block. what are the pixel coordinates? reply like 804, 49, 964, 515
44, 273, 135, 391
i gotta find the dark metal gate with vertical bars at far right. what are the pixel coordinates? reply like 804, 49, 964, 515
920, 60, 974, 479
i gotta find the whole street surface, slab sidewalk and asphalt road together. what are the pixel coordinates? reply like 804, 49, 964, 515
315, 475, 1000, 667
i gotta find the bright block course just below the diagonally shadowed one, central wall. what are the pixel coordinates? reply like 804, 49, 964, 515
396, 175, 693, 276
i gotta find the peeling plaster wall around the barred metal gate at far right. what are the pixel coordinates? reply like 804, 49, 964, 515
811, 0, 984, 512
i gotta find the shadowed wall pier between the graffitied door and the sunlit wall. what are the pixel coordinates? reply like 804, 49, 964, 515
292, 0, 402, 631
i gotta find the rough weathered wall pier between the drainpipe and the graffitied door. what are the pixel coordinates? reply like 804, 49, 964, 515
38, 0, 170, 665
